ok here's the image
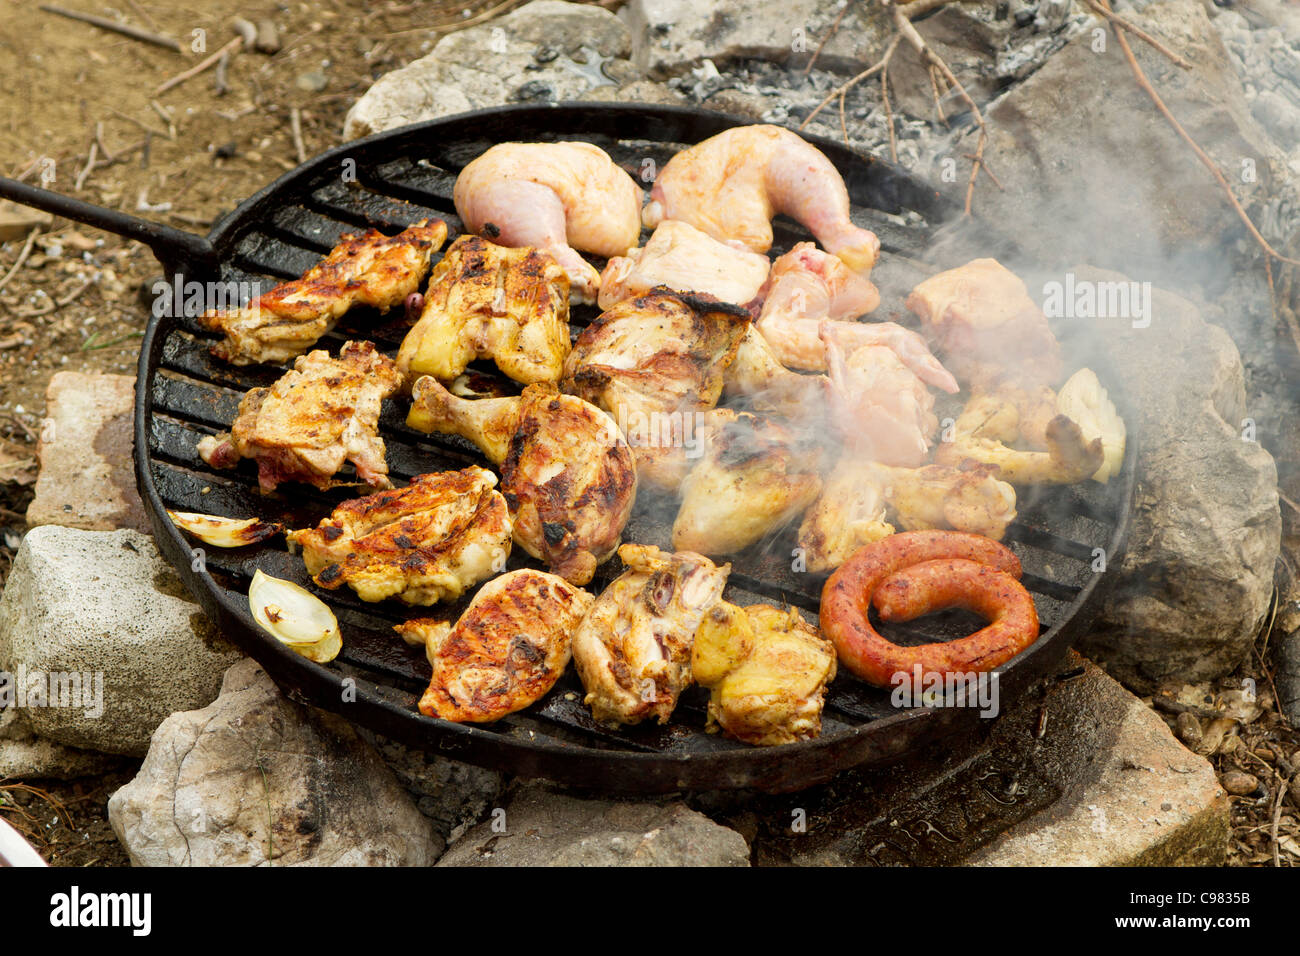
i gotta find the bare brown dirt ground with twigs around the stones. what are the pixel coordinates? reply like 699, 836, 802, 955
0, 0, 1300, 866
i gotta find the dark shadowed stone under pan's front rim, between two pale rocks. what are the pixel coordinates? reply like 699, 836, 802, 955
361, 731, 506, 843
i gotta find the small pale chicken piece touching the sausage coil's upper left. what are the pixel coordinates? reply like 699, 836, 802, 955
800, 455, 894, 574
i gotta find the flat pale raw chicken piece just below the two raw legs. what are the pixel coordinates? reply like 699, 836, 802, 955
599, 220, 772, 308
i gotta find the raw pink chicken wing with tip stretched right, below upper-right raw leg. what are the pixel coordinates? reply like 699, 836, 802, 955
758, 242, 957, 392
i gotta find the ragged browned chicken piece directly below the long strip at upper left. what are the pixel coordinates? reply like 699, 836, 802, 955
199, 342, 402, 493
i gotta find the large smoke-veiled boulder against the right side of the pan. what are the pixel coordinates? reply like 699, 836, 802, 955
1055, 267, 1282, 689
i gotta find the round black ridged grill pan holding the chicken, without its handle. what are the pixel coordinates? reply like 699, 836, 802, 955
126, 103, 1136, 792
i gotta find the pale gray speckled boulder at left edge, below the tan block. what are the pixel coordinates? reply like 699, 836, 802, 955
0, 525, 241, 756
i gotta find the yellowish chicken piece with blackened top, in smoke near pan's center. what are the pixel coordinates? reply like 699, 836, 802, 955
672, 408, 822, 554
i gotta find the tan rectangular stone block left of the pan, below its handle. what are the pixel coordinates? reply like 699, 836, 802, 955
27, 372, 150, 532
